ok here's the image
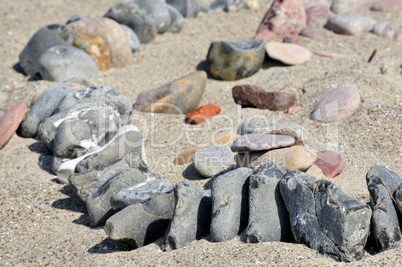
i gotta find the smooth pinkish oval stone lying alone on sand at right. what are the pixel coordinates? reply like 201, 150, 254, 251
310, 86, 361, 123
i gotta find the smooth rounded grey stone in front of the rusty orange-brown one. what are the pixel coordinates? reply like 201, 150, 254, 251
39, 45, 98, 82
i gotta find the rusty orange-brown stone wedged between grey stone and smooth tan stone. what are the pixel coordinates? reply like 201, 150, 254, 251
73, 32, 112, 71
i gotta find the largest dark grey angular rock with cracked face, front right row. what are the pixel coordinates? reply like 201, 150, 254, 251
279, 170, 371, 261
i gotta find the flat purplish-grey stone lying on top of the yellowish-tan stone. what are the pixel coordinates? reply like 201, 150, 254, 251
230, 134, 295, 153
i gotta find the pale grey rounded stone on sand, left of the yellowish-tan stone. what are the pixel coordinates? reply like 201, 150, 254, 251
193, 145, 233, 177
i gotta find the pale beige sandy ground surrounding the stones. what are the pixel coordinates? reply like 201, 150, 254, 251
0, 0, 402, 266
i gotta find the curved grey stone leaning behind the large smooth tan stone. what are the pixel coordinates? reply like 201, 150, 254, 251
104, 0, 157, 44
